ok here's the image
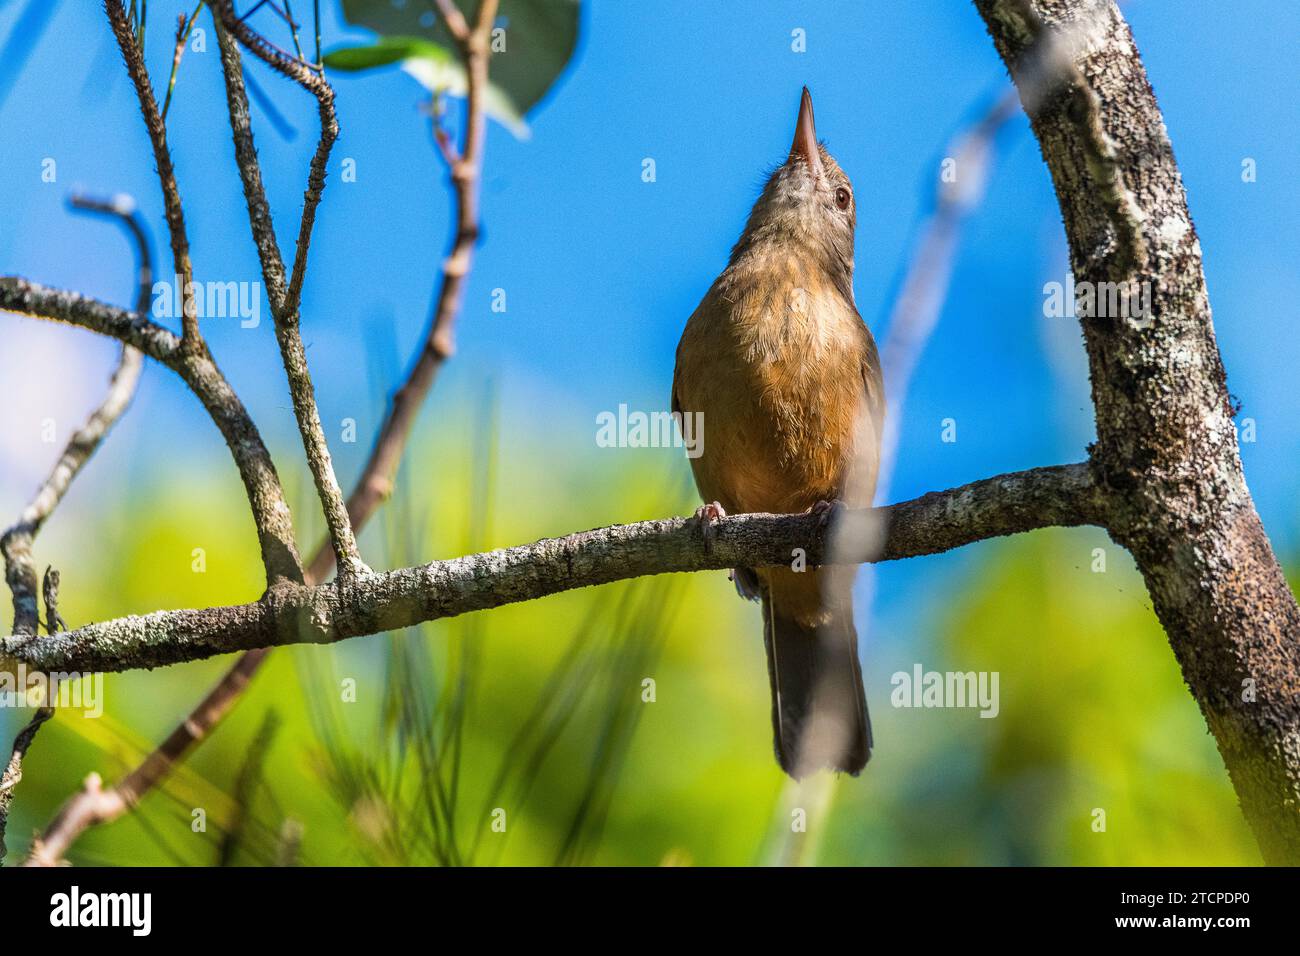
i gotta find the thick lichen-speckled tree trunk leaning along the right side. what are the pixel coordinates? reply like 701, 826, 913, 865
975, 0, 1300, 864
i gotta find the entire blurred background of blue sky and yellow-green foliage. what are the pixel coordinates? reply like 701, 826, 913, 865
0, 0, 1300, 865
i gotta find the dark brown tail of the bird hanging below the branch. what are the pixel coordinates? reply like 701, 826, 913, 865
762, 574, 871, 779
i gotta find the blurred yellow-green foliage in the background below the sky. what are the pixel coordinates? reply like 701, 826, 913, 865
3, 397, 1258, 865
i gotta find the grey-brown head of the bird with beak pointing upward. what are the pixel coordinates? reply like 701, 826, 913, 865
732, 87, 857, 280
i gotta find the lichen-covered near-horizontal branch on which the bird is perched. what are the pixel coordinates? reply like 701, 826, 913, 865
0, 464, 1105, 671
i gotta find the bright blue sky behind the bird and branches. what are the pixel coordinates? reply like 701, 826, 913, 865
0, 0, 1300, 632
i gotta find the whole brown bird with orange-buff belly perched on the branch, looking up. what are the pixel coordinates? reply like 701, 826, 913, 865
672, 87, 884, 779
